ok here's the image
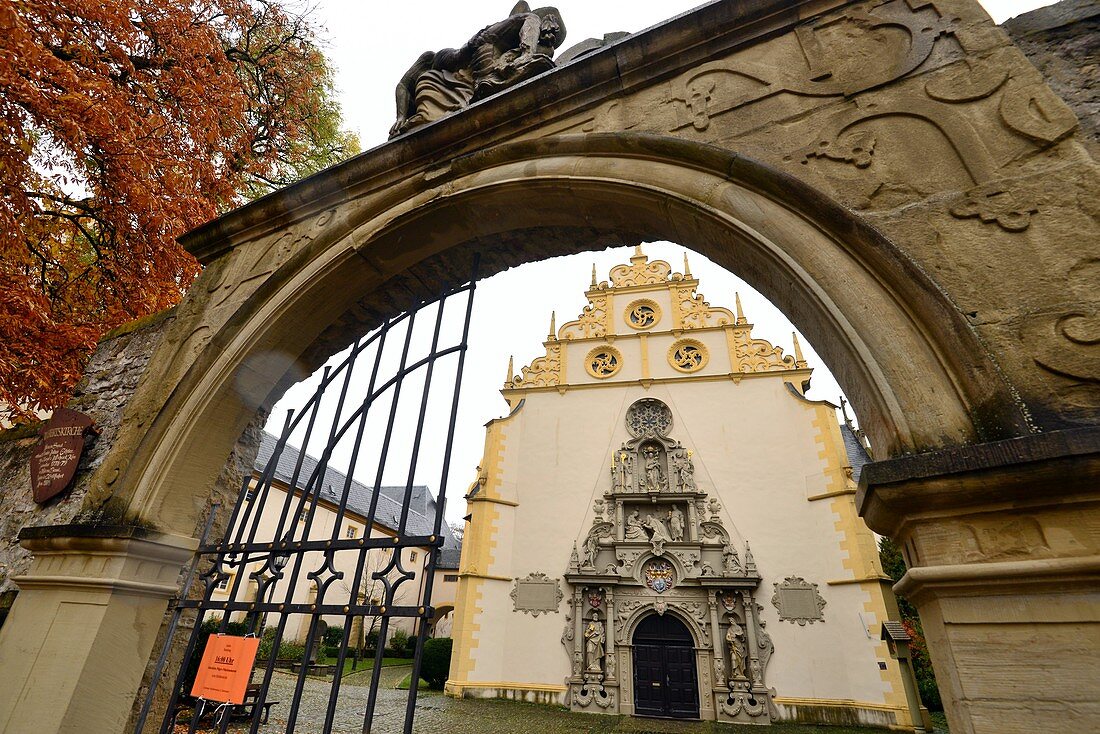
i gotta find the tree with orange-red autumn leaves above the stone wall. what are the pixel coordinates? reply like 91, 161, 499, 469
0, 0, 359, 417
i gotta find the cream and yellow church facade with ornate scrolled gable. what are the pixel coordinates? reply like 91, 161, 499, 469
447, 250, 924, 730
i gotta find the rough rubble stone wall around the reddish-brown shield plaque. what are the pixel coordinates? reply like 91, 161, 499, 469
0, 309, 175, 592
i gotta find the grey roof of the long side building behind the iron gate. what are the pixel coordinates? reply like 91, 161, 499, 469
253, 431, 461, 548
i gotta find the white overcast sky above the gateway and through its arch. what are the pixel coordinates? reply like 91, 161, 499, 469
268, 0, 1048, 528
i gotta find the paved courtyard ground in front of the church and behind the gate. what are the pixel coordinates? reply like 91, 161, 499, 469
243, 666, 944, 734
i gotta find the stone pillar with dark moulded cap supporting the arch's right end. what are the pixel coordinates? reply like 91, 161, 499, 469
857, 428, 1100, 734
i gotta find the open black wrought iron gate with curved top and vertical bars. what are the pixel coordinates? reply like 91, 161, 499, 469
135, 259, 477, 734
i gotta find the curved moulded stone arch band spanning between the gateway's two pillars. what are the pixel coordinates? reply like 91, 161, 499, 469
103, 133, 1026, 533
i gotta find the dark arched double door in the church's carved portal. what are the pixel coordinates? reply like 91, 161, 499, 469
633, 614, 699, 719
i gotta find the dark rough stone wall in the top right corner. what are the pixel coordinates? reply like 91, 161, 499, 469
1001, 0, 1100, 157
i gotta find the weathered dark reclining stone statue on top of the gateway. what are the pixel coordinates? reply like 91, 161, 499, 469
389, 1, 565, 138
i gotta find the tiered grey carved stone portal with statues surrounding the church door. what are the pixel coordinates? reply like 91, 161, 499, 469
562, 398, 774, 723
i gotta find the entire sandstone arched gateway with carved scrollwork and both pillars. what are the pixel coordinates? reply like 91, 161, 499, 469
0, 0, 1100, 734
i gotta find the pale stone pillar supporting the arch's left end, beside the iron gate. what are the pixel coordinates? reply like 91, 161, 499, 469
0, 525, 198, 734
